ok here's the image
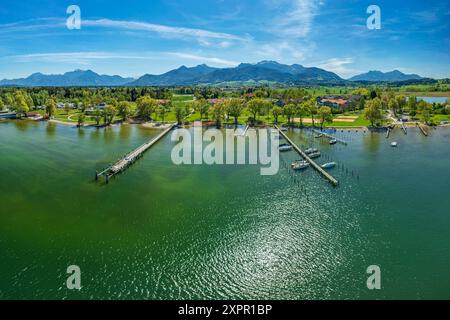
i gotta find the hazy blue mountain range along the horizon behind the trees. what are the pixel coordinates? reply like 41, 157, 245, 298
0, 61, 423, 87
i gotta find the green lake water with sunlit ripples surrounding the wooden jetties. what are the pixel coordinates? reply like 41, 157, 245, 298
0, 121, 450, 299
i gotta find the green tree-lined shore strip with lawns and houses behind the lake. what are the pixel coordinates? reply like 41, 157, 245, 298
0, 87, 450, 128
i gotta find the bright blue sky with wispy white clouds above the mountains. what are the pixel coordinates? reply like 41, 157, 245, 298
0, 0, 450, 79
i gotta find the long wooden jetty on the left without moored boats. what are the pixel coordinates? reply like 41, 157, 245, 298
95, 123, 177, 183
